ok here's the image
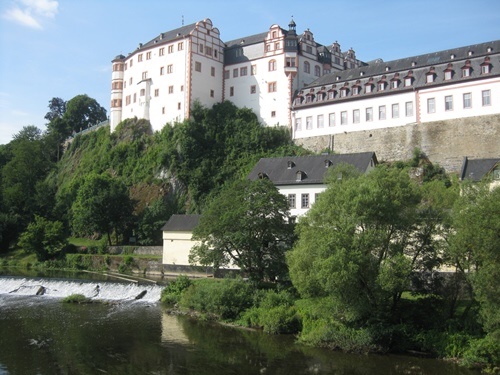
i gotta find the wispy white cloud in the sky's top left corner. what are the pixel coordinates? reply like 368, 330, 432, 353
3, 0, 59, 29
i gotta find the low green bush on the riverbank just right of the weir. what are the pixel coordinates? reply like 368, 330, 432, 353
179, 279, 255, 320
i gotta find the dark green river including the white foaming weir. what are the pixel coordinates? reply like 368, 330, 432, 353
0, 276, 477, 375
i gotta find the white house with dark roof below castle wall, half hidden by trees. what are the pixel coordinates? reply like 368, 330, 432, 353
248, 152, 378, 217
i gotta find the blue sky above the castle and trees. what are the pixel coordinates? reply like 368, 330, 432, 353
0, 0, 500, 144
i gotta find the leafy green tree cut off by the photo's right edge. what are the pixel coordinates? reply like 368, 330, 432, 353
450, 184, 500, 335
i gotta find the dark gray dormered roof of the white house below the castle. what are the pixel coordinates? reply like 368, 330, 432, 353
248, 152, 377, 185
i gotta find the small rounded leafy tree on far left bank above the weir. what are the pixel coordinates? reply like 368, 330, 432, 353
18, 216, 68, 261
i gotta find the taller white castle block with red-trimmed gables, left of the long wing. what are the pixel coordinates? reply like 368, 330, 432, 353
110, 19, 362, 134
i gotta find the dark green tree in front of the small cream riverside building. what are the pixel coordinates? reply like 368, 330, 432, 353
190, 180, 294, 282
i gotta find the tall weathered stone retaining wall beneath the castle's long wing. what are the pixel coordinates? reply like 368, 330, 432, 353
295, 115, 500, 172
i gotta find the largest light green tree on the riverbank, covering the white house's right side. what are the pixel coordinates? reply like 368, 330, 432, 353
287, 166, 448, 322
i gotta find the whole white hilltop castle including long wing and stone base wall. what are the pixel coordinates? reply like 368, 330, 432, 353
110, 19, 500, 170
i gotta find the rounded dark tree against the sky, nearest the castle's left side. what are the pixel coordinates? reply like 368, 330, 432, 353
63, 95, 106, 133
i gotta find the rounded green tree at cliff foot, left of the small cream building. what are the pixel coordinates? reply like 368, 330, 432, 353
71, 173, 133, 245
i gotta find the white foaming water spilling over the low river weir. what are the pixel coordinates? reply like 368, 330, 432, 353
0, 277, 163, 302
